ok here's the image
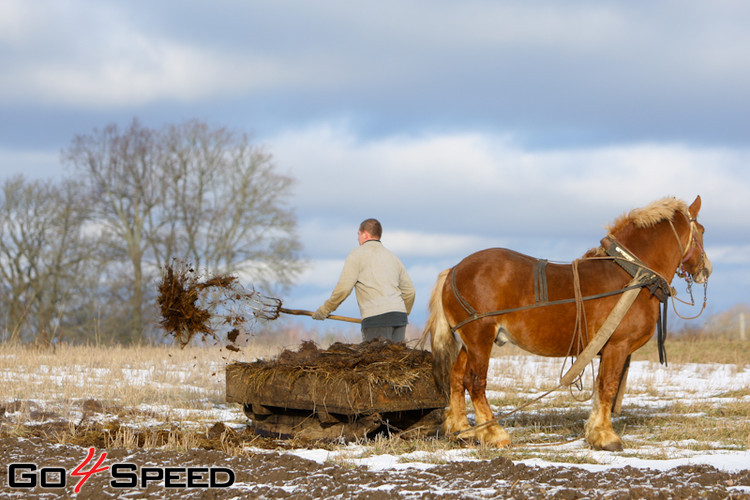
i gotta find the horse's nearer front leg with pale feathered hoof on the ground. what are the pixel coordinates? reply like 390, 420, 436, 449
585, 346, 628, 451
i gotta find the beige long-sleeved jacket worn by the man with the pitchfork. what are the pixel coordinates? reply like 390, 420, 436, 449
318, 240, 415, 318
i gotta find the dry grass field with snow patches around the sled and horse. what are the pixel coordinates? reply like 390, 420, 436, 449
0, 332, 750, 491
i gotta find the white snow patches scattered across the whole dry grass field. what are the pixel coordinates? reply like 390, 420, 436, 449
0, 356, 750, 471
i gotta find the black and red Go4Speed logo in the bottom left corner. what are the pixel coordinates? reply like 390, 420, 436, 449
8, 448, 235, 493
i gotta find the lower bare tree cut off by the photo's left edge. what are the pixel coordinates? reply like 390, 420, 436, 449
0, 176, 91, 344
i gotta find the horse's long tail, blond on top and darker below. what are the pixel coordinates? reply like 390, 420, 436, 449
419, 269, 459, 396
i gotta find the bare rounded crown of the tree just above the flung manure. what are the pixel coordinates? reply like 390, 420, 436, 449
160, 121, 301, 286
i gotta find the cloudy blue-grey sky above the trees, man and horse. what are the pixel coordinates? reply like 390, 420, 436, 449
0, 0, 750, 332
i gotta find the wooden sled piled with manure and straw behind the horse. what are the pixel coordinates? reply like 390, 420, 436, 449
226, 340, 447, 441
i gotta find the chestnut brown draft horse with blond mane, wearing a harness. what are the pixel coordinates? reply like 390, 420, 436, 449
422, 196, 712, 451
